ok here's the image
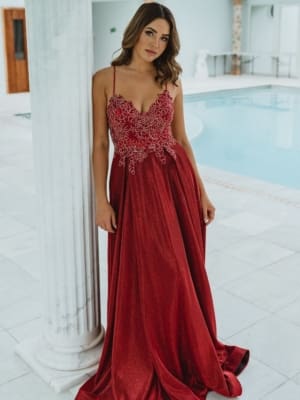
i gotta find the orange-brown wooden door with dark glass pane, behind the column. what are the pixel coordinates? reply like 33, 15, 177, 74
3, 8, 29, 93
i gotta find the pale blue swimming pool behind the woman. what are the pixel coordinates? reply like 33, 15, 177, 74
184, 86, 300, 189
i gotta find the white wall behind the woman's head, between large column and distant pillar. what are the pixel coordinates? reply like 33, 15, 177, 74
93, 0, 232, 76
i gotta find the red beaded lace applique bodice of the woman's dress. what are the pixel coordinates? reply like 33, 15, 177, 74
107, 89, 176, 174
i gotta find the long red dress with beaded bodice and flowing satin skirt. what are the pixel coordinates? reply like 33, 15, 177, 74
76, 67, 249, 400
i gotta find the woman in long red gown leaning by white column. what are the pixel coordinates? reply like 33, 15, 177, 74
76, 3, 249, 400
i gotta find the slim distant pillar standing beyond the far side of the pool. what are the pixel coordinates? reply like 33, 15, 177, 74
231, 0, 242, 75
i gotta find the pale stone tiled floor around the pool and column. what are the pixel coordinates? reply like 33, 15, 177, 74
0, 77, 300, 400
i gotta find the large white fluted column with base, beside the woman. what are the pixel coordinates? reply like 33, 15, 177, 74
17, 0, 104, 391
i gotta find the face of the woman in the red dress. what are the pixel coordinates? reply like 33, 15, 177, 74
133, 18, 170, 62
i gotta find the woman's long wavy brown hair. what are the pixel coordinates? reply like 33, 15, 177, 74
111, 3, 182, 85
